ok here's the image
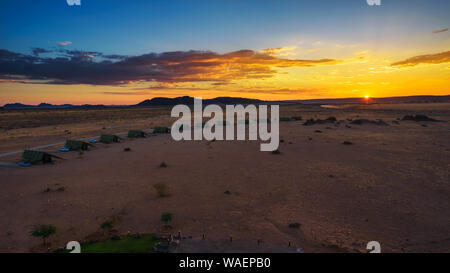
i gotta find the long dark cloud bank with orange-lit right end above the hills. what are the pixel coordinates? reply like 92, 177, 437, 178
0, 49, 340, 85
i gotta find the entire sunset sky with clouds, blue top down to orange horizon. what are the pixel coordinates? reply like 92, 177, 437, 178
0, 0, 450, 105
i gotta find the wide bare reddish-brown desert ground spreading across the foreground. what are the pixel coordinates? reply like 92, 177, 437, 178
0, 104, 450, 252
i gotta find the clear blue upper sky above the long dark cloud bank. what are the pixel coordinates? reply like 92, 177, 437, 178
0, 0, 450, 54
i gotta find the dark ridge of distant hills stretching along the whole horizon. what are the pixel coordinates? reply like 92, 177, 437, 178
2, 95, 450, 109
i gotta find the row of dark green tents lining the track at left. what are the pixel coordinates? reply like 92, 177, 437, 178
19, 127, 170, 166
